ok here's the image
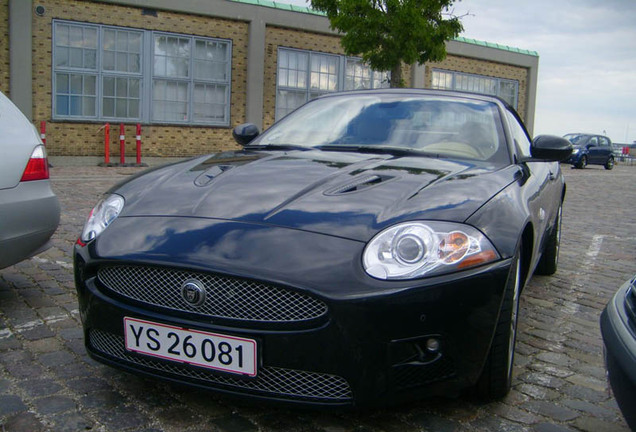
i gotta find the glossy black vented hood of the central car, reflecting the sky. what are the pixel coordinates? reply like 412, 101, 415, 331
111, 150, 519, 241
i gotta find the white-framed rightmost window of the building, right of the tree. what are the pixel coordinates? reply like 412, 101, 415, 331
431, 69, 519, 109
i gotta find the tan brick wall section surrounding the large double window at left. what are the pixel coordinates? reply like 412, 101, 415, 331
31, 0, 248, 157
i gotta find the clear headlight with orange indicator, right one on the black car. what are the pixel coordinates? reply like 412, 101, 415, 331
362, 222, 499, 279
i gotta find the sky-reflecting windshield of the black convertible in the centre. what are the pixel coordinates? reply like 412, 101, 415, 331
250, 93, 510, 163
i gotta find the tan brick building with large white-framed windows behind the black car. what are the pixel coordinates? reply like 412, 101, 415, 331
0, 0, 538, 156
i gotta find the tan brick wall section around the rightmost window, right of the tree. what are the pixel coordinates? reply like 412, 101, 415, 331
425, 55, 529, 119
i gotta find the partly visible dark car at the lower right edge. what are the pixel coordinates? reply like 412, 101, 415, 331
601, 277, 636, 430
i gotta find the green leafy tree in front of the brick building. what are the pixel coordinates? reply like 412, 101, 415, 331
311, 0, 463, 87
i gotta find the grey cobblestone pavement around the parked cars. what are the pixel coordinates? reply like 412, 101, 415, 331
0, 160, 636, 432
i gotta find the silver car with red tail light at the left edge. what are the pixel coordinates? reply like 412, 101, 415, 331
0, 92, 60, 269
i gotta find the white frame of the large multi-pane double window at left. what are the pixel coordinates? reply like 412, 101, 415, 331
52, 19, 233, 127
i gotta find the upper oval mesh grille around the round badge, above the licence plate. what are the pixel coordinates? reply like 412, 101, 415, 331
97, 266, 327, 322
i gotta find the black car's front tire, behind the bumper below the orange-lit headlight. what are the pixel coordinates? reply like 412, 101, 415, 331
474, 247, 521, 402
